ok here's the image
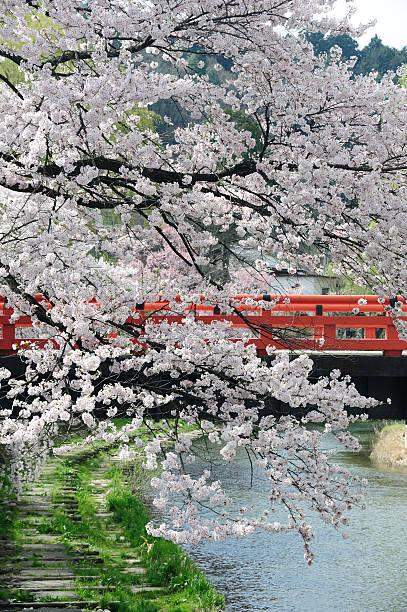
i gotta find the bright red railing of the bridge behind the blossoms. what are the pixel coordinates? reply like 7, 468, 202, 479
0, 294, 407, 356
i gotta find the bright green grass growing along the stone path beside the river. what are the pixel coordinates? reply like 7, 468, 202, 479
0, 419, 224, 612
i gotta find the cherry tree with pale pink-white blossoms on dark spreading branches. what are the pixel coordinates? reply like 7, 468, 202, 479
0, 0, 407, 562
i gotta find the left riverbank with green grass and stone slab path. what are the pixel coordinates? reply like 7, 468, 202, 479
0, 420, 223, 612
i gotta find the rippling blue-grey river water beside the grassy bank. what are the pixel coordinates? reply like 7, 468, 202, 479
179, 423, 407, 612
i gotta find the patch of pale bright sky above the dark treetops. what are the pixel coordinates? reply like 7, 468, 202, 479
338, 0, 407, 49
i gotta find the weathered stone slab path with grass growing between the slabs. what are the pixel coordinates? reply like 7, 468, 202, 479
0, 450, 162, 612
